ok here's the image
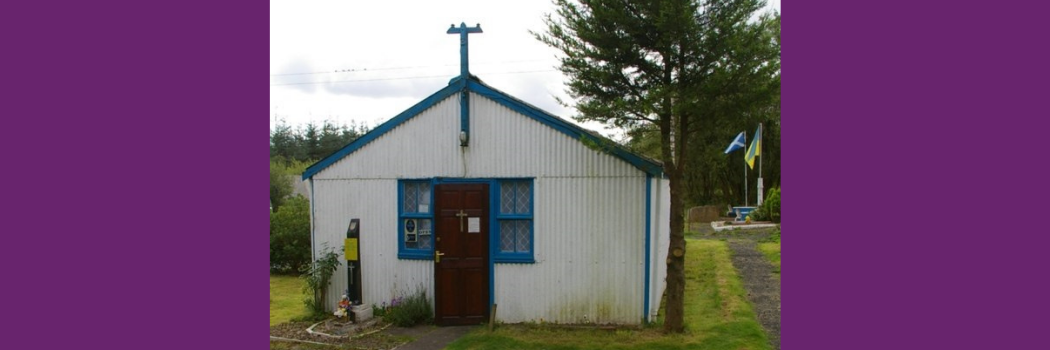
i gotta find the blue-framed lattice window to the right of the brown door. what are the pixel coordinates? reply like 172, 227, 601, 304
496, 180, 534, 263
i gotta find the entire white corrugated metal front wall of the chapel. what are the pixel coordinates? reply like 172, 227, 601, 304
313, 94, 667, 324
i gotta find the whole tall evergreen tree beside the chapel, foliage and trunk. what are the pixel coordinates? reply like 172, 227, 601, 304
534, 0, 779, 332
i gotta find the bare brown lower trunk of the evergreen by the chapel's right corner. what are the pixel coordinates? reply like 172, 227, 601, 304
664, 168, 686, 333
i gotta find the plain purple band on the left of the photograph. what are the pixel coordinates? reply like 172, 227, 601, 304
0, 1, 269, 349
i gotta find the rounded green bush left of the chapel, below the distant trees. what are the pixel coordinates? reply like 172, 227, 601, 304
270, 195, 310, 273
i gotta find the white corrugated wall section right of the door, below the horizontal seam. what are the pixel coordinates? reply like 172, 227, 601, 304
495, 178, 645, 324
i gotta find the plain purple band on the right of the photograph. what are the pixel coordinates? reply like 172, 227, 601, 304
781, 1, 1050, 349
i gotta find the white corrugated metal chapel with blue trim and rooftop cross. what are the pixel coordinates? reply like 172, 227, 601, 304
302, 24, 670, 325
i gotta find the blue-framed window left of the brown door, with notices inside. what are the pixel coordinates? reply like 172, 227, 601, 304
397, 180, 434, 259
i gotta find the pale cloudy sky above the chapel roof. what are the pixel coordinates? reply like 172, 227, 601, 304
270, 0, 780, 140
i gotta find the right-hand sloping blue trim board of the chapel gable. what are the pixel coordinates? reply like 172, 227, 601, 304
466, 79, 664, 177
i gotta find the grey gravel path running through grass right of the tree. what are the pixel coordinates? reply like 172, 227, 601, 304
728, 239, 780, 350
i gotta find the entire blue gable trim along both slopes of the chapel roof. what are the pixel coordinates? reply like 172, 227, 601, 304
302, 76, 665, 180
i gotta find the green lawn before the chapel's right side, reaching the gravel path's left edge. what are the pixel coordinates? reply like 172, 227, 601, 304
447, 240, 770, 350
